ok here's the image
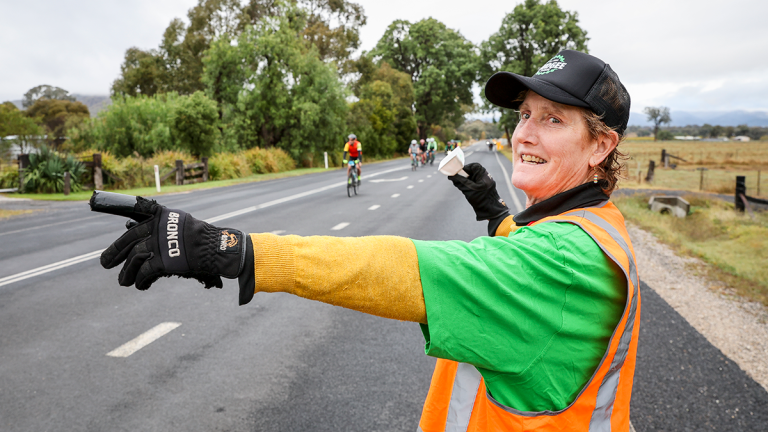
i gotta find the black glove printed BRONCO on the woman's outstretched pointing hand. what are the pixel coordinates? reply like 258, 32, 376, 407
101, 197, 246, 290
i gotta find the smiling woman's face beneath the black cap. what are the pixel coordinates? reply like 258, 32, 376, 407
512, 91, 604, 207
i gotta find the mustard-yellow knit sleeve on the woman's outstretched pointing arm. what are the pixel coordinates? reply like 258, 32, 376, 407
250, 234, 427, 324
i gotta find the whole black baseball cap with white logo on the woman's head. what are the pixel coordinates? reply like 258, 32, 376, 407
485, 50, 630, 135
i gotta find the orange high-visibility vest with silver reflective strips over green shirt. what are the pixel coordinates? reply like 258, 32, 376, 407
419, 201, 640, 432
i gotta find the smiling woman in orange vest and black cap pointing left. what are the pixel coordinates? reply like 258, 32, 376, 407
101, 51, 640, 431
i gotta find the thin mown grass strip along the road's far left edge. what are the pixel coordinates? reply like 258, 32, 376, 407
6, 168, 333, 201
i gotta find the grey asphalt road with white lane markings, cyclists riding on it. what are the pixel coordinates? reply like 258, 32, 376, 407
0, 146, 768, 432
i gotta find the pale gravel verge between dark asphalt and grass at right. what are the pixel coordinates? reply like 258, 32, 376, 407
627, 223, 768, 391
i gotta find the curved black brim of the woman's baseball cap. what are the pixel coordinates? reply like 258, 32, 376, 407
485, 72, 589, 109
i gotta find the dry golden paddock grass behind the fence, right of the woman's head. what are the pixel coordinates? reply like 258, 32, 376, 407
619, 139, 768, 197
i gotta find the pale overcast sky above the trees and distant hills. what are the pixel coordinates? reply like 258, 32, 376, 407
0, 0, 768, 112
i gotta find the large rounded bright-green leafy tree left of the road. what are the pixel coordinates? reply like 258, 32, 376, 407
203, 8, 347, 161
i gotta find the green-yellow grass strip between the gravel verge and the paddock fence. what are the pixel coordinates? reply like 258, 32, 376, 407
612, 194, 768, 306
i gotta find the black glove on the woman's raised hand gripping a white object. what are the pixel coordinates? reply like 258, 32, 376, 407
448, 162, 509, 221
